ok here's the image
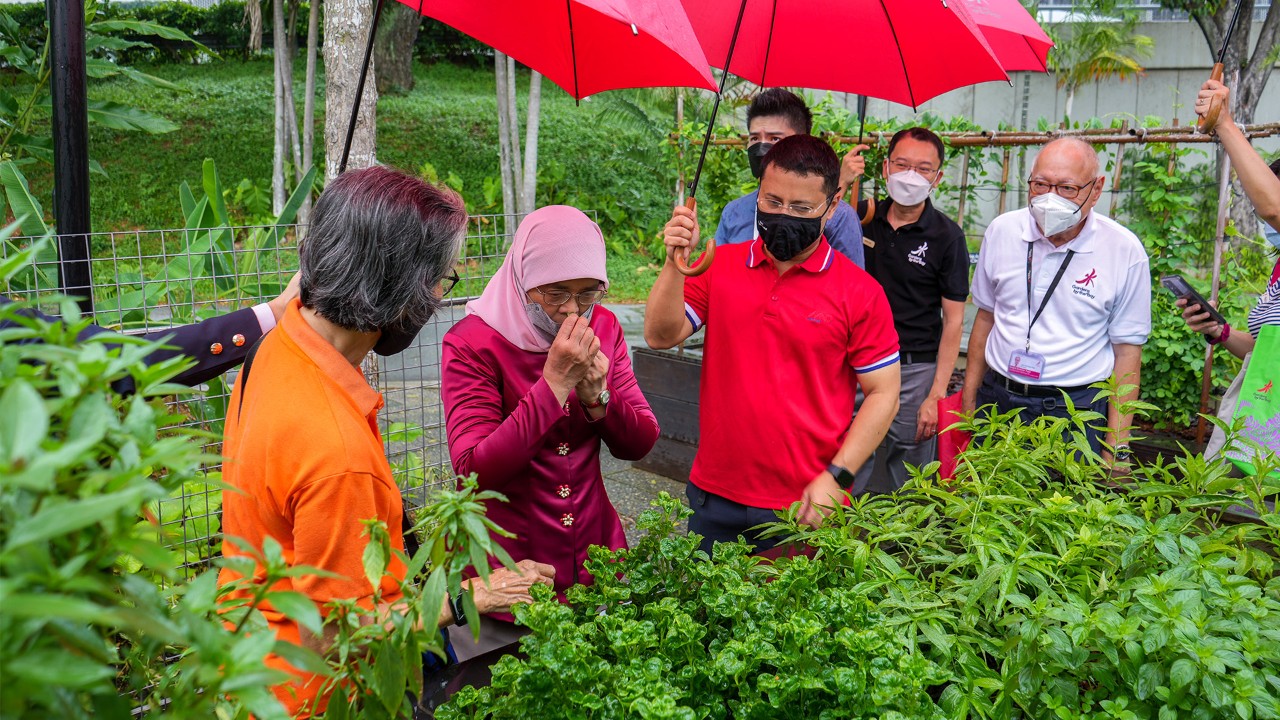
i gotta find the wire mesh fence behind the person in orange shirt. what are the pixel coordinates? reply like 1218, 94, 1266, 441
0, 210, 516, 571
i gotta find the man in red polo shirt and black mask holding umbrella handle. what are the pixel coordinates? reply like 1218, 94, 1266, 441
644, 135, 899, 551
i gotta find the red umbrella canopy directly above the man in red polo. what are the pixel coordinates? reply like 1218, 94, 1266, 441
682, 0, 1009, 108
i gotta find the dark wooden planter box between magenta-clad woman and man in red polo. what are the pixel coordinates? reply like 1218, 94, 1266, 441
631, 346, 703, 482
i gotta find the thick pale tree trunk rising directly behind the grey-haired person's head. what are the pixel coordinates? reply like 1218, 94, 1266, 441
324, 0, 378, 179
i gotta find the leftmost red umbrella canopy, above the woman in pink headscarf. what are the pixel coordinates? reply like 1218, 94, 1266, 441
399, 0, 716, 100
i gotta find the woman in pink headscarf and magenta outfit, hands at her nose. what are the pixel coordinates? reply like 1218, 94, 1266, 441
440, 205, 658, 659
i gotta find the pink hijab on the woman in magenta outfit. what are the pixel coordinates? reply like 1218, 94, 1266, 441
467, 205, 609, 352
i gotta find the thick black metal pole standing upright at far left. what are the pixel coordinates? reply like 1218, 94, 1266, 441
46, 0, 93, 314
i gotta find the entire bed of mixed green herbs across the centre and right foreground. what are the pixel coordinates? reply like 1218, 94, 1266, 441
440, 397, 1280, 720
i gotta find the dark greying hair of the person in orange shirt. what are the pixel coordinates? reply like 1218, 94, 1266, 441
301, 167, 467, 332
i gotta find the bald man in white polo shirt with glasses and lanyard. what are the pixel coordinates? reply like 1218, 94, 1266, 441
964, 138, 1151, 460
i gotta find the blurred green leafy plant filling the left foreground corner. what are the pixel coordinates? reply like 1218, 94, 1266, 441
0, 233, 309, 719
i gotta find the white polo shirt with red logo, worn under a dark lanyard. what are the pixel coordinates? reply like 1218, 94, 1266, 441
972, 208, 1151, 387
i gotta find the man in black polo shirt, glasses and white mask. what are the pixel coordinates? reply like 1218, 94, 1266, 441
859, 127, 969, 492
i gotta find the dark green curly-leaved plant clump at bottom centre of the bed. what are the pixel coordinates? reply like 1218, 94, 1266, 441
438, 493, 948, 720
